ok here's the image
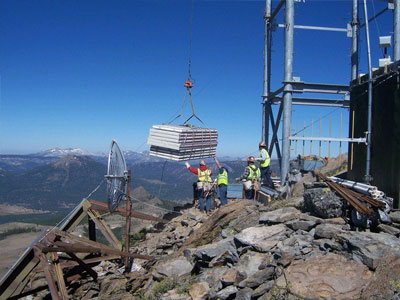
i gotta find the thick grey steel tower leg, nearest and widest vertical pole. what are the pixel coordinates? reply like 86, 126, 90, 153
281, 0, 294, 186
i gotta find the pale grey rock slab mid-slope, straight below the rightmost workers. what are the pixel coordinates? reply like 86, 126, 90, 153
235, 224, 287, 252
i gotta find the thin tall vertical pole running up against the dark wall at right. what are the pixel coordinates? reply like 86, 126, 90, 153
364, 0, 374, 183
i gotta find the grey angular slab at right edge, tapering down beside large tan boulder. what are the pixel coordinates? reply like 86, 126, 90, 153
337, 231, 400, 270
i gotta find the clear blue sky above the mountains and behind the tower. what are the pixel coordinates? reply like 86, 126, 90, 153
0, 0, 393, 155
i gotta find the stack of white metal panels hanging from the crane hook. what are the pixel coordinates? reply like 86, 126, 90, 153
147, 125, 218, 161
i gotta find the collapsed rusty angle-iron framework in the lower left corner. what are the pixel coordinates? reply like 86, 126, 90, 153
0, 199, 167, 300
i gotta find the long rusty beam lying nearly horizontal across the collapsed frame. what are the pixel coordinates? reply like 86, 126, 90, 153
42, 242, 153, 260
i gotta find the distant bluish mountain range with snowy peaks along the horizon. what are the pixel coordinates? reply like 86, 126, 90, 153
0, 148, 274, 210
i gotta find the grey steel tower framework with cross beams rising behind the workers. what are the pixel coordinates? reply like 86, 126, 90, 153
262, 0, 400, 186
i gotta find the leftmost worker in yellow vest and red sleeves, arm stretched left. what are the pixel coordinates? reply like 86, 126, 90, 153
185, 160, 212, 213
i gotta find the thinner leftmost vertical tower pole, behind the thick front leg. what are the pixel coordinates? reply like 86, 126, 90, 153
261, 0, 272, 145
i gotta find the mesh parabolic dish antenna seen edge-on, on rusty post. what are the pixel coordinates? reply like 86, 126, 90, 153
105, 140, 128, 212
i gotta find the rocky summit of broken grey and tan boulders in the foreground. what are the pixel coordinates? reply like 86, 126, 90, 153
24, 196, 400, 300
